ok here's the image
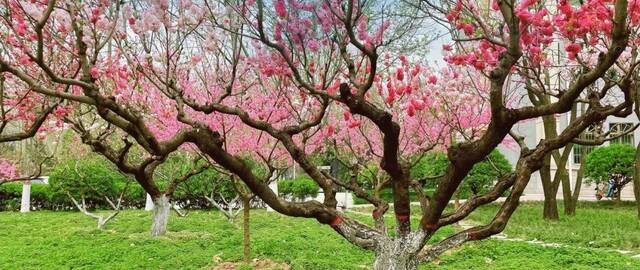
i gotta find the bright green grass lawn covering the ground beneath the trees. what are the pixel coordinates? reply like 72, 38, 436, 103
0, 201, 640, 270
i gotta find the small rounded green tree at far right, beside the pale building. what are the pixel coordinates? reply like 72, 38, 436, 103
584, 144, 635, 200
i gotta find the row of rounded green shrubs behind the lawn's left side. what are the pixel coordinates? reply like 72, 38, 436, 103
0, 156, 226, 211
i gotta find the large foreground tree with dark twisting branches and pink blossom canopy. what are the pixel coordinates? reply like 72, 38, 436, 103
0, 0, 640, 269
